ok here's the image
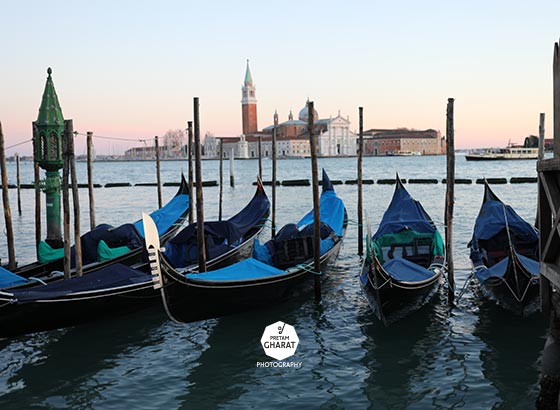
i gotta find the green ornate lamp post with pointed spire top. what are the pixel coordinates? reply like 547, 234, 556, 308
35, 67, 64, 248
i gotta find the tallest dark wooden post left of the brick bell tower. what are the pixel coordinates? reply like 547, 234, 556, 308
194, 97, 206, 272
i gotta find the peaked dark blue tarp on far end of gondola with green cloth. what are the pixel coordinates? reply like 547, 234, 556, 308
373, 182, 436, 239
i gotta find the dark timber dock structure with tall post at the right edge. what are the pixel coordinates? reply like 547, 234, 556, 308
536, 42, 560, 410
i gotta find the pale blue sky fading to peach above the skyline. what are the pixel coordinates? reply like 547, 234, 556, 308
0, 0, 560, 156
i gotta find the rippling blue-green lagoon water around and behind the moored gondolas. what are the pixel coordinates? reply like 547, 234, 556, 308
0, 156, 546, 409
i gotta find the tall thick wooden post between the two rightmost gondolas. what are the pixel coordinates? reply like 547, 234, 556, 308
445, 98, 455, 305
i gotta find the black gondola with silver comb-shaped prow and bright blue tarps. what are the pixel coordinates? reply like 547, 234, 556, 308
145, 171, 347, 323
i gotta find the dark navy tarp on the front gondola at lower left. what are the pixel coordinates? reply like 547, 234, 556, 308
10, 263, 151, 303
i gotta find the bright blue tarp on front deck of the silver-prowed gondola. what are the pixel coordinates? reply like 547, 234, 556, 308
186, 258, 286, 281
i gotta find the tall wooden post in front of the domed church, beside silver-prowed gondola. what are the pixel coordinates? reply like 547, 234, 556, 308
307, 101, 321, 302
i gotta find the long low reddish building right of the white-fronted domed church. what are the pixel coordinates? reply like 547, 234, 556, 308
364, 128, 446, 155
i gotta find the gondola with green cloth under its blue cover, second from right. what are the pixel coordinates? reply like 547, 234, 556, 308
360, 175, 446, 325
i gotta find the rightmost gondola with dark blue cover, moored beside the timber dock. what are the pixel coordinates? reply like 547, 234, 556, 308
468, 181, 539, 316
